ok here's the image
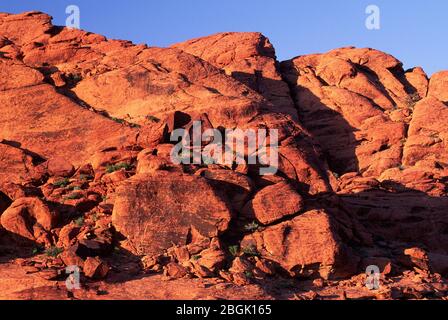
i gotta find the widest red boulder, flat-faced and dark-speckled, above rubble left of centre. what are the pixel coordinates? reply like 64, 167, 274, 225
112, 172, 231, 255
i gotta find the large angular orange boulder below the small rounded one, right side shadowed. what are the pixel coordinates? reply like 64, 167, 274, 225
241, 210, 359, 278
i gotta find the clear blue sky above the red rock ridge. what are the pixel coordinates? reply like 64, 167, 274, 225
0, 0, 448, 74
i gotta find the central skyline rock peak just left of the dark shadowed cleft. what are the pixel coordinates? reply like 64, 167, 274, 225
174, 32, 297, 119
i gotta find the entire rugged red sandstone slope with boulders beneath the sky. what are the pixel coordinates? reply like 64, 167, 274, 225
0, 12, 448, 299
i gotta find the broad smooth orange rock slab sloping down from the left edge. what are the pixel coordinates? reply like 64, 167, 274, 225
0, 60, 135, 165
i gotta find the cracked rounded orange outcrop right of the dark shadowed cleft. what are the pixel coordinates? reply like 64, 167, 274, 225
282, 48, 416, 175
